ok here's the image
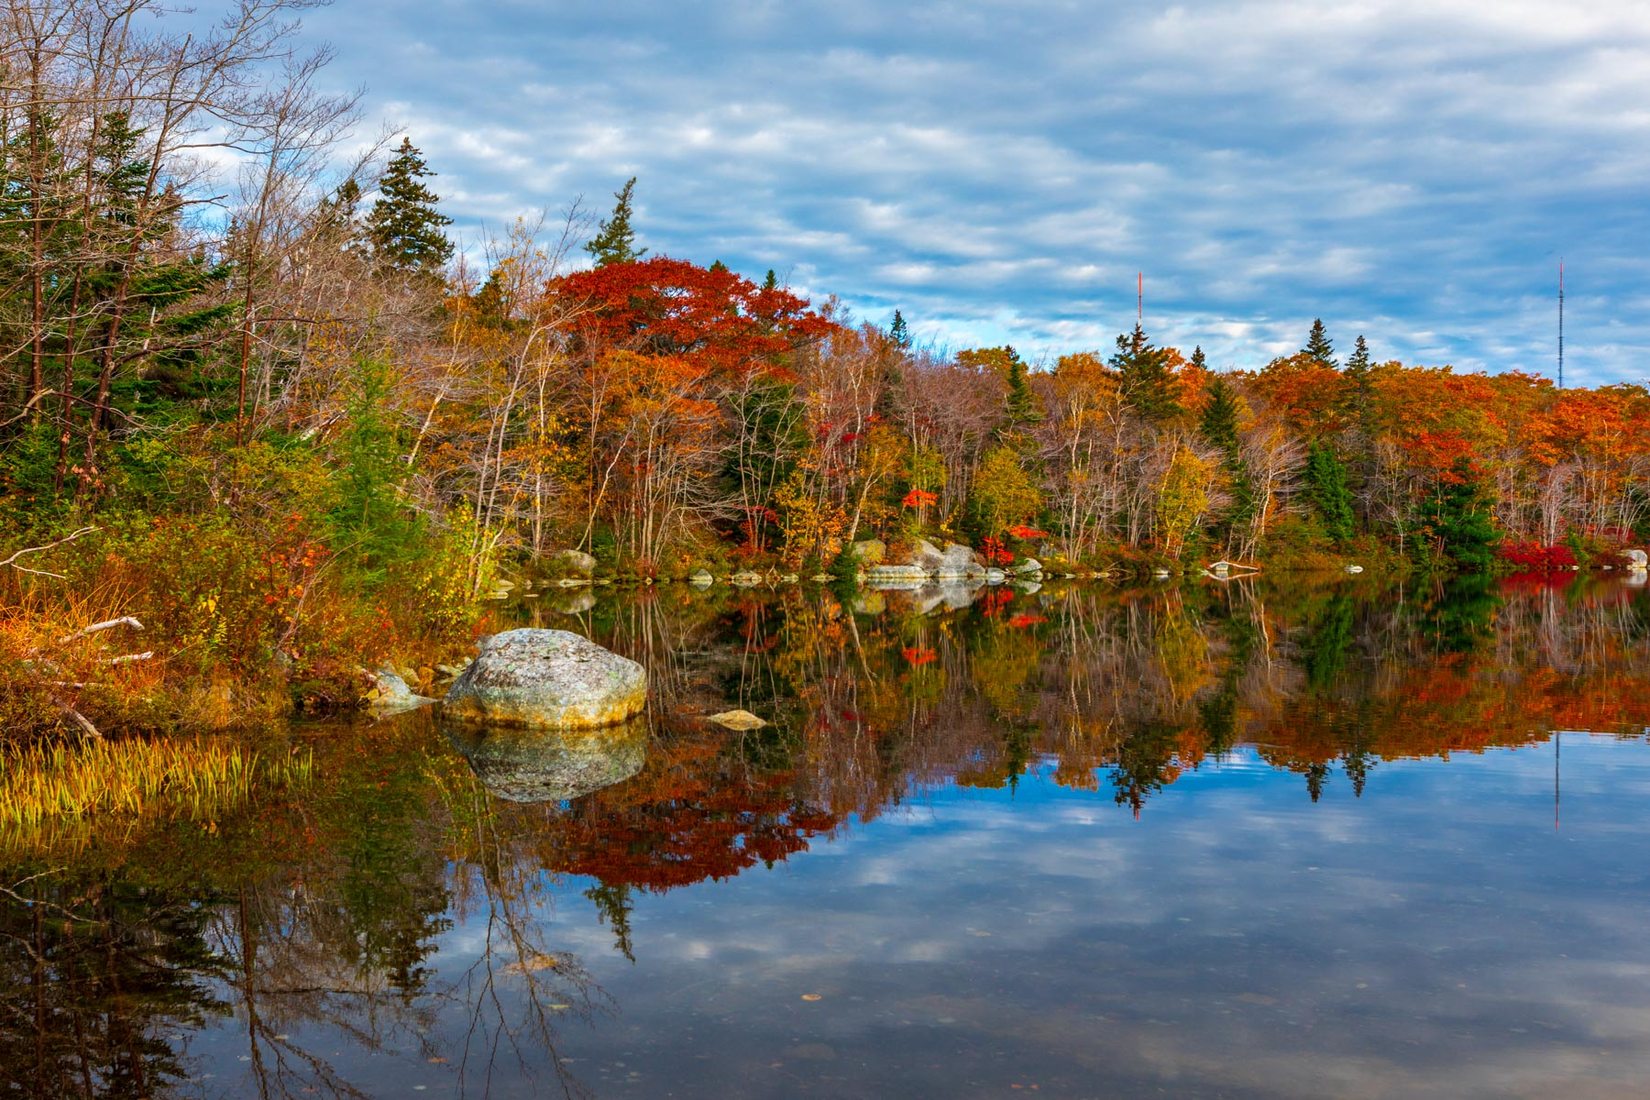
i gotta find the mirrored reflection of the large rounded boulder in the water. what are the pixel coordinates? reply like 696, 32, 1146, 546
442, 719, 647, 801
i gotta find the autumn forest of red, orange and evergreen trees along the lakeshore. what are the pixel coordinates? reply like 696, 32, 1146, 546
0, 0, 1650, 734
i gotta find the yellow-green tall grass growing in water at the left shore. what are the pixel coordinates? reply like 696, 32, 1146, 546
0, 739, 315, 828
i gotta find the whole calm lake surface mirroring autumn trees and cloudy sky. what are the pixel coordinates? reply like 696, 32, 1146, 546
0, 582, 1650, 1098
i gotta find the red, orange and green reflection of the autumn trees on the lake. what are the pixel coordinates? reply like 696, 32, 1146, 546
0, 581, 1650, 1097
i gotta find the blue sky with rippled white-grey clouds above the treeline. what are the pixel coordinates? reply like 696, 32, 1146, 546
304, 0, 1650, 384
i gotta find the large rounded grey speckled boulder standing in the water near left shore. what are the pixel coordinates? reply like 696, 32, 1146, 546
442, 628, 647, 729
